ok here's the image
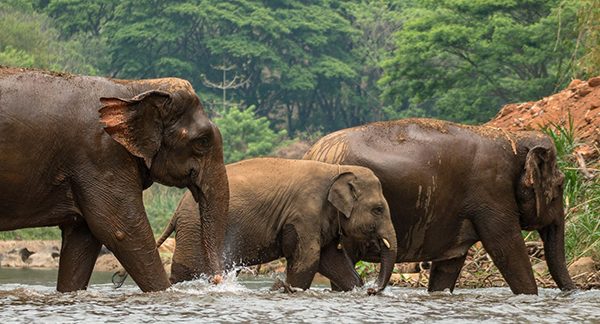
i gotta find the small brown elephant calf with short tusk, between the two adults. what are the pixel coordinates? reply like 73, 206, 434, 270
158, 158, 396, 293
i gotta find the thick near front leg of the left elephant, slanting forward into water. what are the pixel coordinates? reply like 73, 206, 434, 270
78, 175, 171, 292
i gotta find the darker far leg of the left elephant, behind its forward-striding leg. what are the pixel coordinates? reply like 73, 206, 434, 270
56, 222, 102, 292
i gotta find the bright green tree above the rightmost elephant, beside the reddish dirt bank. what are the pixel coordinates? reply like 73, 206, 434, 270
380, 0, 576, 123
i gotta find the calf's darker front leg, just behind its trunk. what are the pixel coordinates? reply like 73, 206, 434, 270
319, 242, 364, 291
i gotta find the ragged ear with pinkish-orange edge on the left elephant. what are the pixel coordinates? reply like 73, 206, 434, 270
99, 90, 171, 168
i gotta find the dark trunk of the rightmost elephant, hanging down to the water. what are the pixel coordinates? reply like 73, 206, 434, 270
538, 218, 576, 290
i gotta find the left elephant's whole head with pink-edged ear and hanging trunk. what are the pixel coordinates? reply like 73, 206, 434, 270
100, 79, 229, 273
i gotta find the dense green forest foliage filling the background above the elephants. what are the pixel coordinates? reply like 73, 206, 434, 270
0, 0, 600, 130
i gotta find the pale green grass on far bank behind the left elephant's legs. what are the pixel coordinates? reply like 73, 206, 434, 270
0, 184, 185, 240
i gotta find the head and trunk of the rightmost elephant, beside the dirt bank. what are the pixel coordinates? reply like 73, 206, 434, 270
516, 133, 575, 289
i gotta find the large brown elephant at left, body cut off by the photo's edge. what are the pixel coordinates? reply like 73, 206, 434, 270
0, 67, 229, 292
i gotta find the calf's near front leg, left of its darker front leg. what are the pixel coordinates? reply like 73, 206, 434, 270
281, 225, 321, 290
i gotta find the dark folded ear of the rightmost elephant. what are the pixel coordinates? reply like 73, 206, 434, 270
523, 146, 554, 218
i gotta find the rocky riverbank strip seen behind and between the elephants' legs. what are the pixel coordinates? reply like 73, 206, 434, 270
0, 238, 600, 290
